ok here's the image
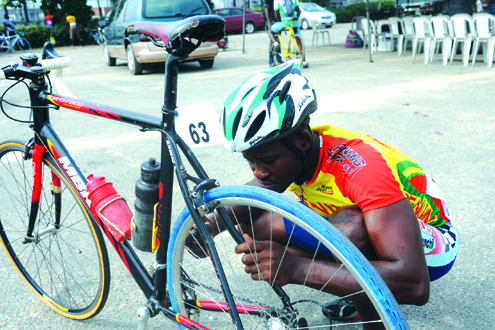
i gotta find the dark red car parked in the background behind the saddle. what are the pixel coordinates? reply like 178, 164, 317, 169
215, 7, 265, 33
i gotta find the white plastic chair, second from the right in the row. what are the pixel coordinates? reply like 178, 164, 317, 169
450, 14, 476, 66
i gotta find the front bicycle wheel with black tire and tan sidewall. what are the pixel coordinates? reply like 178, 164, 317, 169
0, 140, 110, 320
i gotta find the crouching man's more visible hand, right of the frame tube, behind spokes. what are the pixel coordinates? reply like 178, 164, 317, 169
235, 234, 299, 286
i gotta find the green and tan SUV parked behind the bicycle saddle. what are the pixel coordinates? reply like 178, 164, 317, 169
99, 0, 218, 75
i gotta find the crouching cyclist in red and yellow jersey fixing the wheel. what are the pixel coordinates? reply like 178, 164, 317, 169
193, 61, 458, 329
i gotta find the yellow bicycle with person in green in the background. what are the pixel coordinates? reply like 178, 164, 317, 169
272, 18, 309, 68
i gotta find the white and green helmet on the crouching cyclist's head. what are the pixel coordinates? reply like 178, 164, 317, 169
220, 61, 317, 152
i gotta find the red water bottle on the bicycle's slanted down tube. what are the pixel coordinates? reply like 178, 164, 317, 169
86, 174, 132, 242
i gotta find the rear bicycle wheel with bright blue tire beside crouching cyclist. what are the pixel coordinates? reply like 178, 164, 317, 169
167, 186, 409, 330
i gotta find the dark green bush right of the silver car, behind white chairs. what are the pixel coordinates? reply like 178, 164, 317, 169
329, 0, 395, 23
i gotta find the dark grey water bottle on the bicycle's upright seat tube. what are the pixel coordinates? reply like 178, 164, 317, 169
132, 158, 160, 252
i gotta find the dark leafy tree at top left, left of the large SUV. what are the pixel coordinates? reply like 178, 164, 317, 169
40, 0, 94, 26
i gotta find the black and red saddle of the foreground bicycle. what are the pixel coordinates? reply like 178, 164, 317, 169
124, 15, 225, 58
